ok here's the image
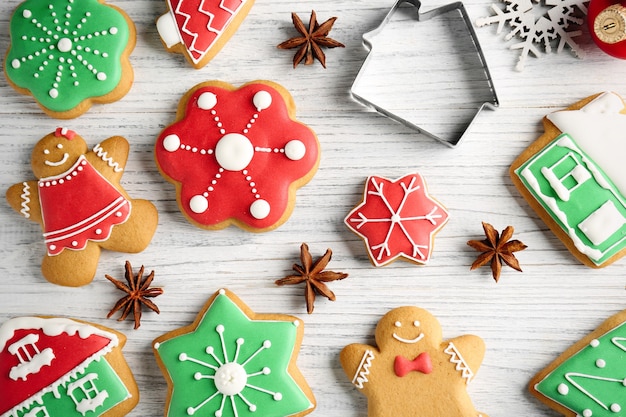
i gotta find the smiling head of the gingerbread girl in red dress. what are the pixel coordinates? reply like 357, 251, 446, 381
31, 129, 87, 178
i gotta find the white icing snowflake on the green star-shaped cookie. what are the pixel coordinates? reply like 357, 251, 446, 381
178, 324, 282, 417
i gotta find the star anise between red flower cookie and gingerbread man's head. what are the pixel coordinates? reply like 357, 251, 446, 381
276, 243, 348, 314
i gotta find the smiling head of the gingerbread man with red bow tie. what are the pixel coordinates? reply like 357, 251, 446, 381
376, 307, 442, 352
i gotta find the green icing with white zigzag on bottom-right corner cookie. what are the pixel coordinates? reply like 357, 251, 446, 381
533, 316, 626, 417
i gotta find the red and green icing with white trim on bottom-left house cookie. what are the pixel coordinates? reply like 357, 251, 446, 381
0, 317, 131, 417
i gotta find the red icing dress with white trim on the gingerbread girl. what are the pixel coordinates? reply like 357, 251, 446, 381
39, 155, 131, 255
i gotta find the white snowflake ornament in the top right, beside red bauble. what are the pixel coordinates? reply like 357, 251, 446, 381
476, 0, 589, 71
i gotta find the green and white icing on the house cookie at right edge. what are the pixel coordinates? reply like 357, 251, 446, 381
516, 93, 626, 266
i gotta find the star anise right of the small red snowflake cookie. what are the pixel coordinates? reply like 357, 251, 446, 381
467, 222, 527, 282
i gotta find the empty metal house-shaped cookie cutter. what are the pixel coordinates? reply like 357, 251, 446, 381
350, 0, 499, 147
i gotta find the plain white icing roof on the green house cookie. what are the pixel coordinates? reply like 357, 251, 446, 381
547, 92, 626, 196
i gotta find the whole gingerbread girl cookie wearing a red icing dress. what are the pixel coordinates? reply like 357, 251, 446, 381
6, 128, 158, 286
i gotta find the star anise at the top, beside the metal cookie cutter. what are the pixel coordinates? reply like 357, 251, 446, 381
278, 10, 345, 68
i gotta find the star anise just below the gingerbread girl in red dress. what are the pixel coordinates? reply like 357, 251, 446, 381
105, 261, 163, 329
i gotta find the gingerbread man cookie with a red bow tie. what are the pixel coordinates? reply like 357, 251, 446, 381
340, 307, 487, 417
